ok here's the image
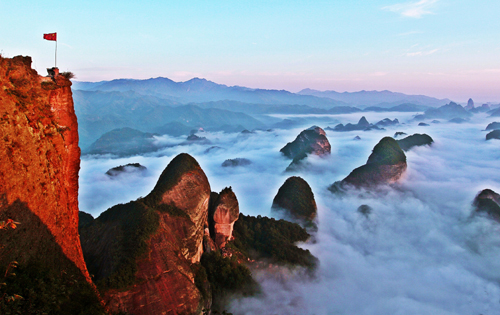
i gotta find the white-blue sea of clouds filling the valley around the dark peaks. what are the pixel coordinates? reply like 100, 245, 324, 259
79, 113, 500, 315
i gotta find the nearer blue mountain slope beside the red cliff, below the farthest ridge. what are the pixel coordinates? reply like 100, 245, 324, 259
73, 90, 265, 149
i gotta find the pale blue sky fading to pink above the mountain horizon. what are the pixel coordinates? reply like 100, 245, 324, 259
0, 0, 500, 102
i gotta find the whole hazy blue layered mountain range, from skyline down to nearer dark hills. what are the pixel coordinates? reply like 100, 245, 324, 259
73, 77, 458, 150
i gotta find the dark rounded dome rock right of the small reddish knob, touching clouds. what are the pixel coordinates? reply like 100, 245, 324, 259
271, 176, 317, 226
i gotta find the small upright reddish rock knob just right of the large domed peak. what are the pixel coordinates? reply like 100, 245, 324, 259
209, 187, 240, 248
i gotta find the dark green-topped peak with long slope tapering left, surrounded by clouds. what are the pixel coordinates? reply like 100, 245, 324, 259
329, 137, 406, 192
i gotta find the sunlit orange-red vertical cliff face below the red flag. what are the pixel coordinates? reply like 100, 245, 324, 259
0, 56, 90, 282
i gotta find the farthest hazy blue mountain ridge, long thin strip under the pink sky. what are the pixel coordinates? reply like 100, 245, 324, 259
73, 77, 450, 109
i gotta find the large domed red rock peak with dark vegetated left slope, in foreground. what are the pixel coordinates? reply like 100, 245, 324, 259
80, 153, 211, 315
